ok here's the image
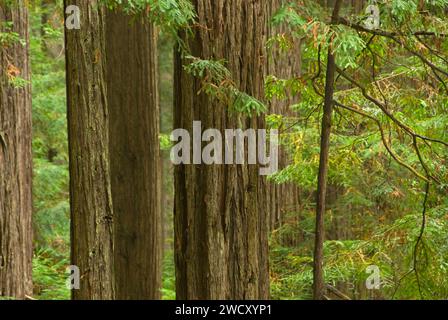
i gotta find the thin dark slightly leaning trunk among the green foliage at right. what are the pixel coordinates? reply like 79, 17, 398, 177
313, 0, 342, 300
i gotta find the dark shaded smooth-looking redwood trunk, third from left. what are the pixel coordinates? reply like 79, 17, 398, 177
106, 11, 163, 299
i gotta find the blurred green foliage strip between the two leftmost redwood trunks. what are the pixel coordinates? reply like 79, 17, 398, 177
30, 0, 70, 299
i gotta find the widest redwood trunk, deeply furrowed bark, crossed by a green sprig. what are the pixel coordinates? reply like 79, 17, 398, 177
174, 0, 269, 299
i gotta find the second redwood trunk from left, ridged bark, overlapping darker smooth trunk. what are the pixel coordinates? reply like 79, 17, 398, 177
65, 0, 115, 300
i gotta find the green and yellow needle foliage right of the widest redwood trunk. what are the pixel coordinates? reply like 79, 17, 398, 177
266, 0, 448, 299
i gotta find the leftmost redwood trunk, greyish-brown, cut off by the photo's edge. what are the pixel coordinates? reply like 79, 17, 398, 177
0, 0, 33, 299
